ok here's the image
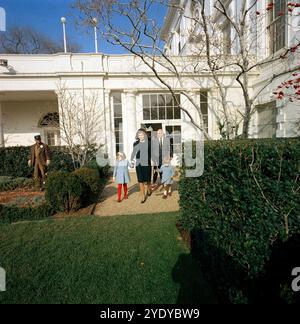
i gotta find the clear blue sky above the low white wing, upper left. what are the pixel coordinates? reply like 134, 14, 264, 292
0, 0, 165, 53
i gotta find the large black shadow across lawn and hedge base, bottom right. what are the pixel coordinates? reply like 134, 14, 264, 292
178, 231, 300, 304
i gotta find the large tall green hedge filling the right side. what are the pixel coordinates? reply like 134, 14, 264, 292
179, 139, 300, 302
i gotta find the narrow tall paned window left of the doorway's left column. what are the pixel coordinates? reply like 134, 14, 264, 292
112, 93, 124, 153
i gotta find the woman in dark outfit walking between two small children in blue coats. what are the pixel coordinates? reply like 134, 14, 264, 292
131, 128, 152, 204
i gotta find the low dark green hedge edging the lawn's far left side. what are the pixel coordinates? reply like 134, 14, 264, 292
0, 204, 53, 224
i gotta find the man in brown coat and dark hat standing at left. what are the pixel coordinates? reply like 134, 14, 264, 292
28, 135, 50, 191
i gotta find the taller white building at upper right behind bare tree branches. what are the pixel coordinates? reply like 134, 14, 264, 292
162, 0, 300, 137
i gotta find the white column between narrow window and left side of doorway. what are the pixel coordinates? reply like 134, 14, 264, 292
122, 90, 137, 158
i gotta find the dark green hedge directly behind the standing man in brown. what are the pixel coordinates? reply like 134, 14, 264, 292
0, 146, 74, 178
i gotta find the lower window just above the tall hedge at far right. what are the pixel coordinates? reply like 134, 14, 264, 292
256, 101, 277, 138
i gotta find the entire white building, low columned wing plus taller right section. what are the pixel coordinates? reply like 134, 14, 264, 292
0, 0, 300, 162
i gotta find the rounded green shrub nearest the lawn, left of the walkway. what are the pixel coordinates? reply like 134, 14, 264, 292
46, 172, 88, 213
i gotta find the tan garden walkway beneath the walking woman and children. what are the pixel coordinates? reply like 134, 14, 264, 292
94, 173, 179, 216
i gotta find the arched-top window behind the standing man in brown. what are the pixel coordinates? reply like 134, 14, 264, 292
39, 112, 60, 146
